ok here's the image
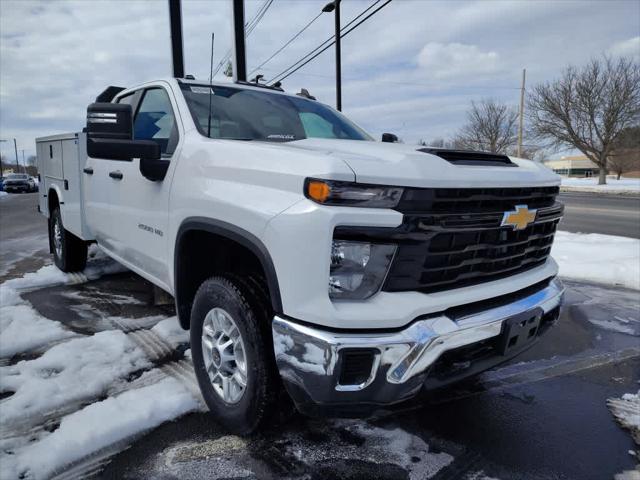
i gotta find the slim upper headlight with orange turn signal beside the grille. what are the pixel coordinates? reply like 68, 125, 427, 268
304, 178, 403, 208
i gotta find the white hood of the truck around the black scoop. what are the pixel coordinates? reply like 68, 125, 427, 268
280, 138, 560, 188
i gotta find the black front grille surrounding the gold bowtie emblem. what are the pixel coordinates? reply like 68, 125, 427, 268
336, 187, 564, 293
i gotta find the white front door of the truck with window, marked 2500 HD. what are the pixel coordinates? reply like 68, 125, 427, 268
111, 85, 182, 285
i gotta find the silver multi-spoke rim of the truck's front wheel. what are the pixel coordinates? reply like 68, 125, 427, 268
202, 308, 247, 404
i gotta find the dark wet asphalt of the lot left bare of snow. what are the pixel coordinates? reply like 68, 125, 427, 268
0, 194, 640, 480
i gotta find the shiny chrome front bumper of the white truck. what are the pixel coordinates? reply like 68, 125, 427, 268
272, 278, 564, 416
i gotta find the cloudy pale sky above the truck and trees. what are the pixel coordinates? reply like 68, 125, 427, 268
0, 0, 640, 159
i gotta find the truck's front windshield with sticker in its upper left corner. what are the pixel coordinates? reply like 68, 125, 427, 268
181, 84, 373, 142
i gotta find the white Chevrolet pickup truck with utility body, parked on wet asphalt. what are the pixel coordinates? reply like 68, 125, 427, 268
37, 79, 564, 433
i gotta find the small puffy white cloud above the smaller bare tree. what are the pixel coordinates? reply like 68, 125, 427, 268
417, 42, 500, 79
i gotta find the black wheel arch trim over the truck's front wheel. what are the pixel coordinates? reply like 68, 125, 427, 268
174, 217, 282, 329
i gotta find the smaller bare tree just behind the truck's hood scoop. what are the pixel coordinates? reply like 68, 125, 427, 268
453, 99, 518, 153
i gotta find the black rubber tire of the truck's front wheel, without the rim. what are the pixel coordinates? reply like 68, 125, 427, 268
190, 275, 279, 435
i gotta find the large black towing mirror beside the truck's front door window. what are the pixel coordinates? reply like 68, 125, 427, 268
86, 103, 160, 161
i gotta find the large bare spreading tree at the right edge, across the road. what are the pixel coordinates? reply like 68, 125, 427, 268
527, 57, 640, 184
